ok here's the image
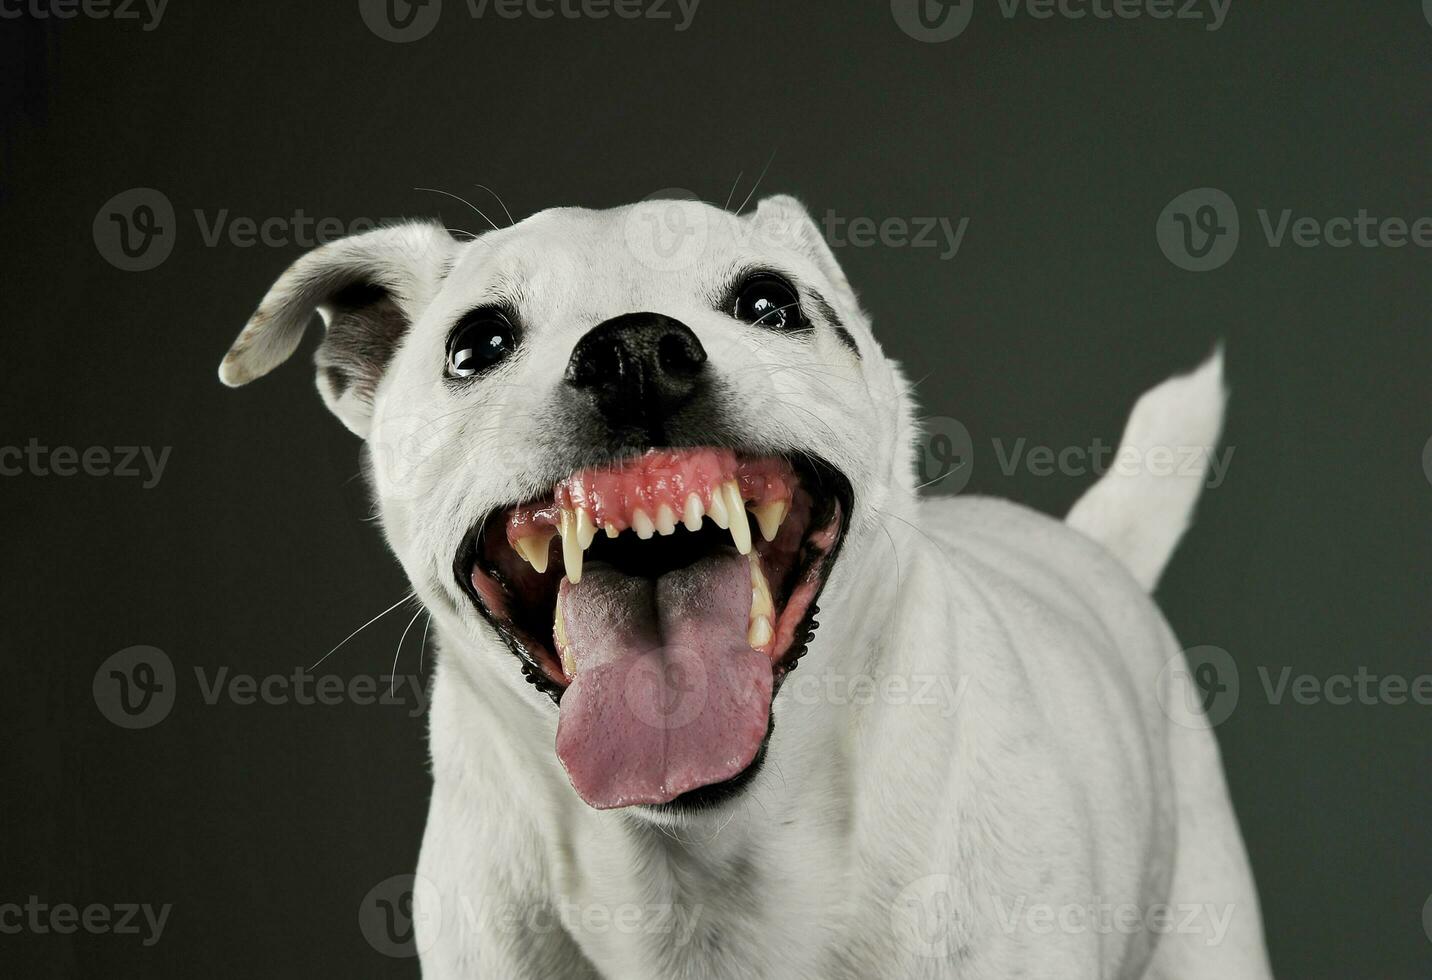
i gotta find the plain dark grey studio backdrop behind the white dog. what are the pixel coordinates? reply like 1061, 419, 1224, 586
0, 0, 1432, 977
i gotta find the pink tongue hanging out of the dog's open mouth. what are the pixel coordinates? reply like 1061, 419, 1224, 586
557, 552, 772, 810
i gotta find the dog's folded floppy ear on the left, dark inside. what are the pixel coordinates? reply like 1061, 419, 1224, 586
219, 222, 457, 436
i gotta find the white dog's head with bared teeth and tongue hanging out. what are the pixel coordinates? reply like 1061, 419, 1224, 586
219, 198, 912, 808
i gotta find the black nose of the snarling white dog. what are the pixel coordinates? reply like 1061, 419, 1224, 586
567, 312, 706, 433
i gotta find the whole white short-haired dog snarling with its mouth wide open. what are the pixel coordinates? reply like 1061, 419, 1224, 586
219, 198, 1269, 980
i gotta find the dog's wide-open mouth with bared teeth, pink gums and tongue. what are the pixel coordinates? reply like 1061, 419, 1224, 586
455, 448, 852, 810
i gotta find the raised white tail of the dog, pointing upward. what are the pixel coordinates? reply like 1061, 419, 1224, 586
1065, 345, 1227, 590
